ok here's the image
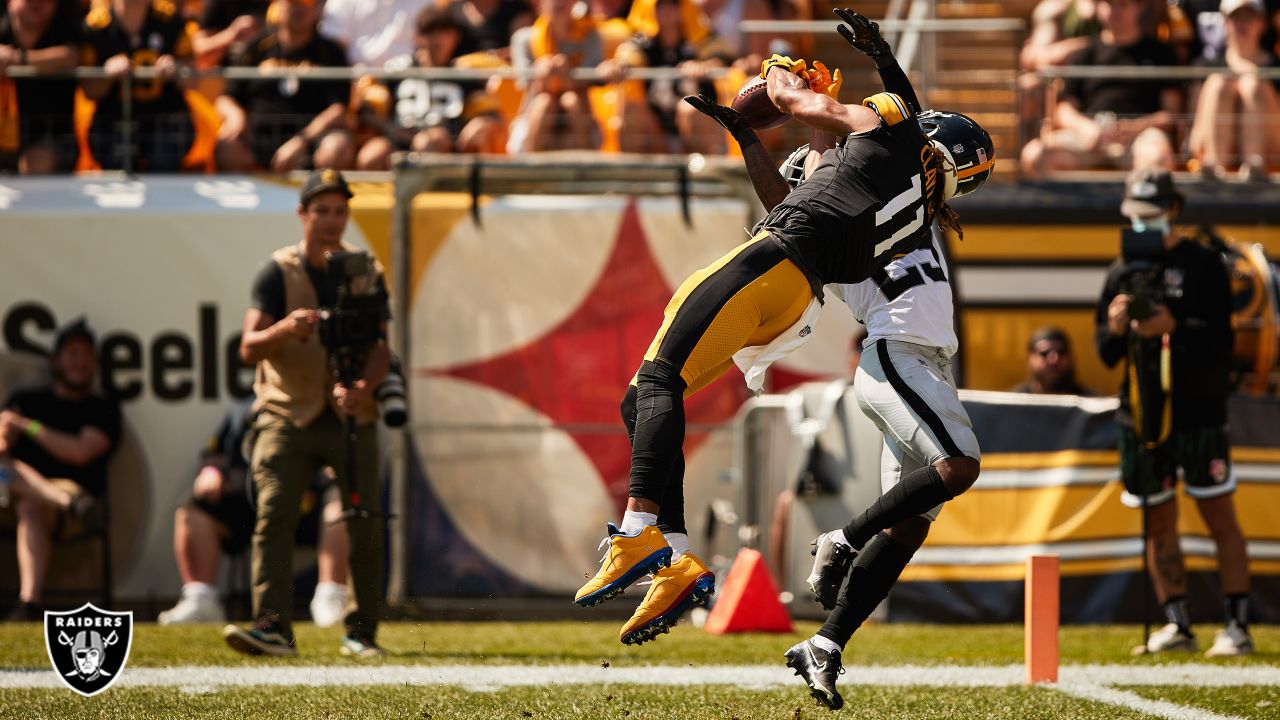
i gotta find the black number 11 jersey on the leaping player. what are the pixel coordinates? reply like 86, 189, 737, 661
763, 118, 943, 297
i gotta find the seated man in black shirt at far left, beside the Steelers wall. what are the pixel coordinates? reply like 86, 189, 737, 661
0, 319, 120, 621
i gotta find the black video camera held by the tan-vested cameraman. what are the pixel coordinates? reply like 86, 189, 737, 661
319, 251, 387, 386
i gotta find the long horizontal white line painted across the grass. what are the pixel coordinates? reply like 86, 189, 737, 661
0, 664, 1280, 691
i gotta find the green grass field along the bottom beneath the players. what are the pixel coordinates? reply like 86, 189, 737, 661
0, 621, 1280, 720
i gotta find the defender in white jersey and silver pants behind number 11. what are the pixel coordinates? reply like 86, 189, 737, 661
732, 92, 980, 708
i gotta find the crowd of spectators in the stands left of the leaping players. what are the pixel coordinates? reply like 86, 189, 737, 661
0, 0, 813, 173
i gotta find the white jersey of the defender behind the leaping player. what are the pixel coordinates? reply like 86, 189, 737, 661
829, 225, 960, 357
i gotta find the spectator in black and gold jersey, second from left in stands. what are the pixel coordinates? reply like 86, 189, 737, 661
82, 0, 196, 173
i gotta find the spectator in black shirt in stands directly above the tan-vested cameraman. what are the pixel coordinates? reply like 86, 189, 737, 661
216, 0, 356, 172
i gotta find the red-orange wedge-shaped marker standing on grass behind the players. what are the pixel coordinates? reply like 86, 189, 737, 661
705, 547, 791, 635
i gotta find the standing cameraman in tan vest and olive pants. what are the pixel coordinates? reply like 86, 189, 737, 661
223, 169, 390, 657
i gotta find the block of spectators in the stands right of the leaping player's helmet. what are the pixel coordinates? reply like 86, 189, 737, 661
1020, 0, 1280, 181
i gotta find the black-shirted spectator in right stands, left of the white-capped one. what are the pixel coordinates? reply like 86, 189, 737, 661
1021, 0, 1181, 177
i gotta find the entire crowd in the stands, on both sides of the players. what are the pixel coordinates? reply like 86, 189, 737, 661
0, 0, 1280, 181
